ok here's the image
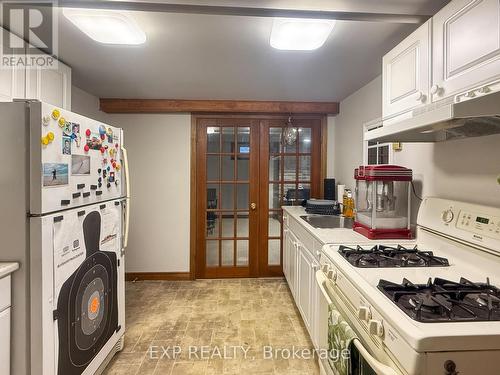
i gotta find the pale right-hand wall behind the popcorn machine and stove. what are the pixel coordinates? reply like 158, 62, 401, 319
328, 76, 500, 217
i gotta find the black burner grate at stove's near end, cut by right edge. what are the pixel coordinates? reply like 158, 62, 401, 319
378, 277, 500, 322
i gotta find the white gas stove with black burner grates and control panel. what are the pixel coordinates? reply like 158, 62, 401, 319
317, 198, 500, 375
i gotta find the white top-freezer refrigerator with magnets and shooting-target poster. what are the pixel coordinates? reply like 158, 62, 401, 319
0, 101, 129, 375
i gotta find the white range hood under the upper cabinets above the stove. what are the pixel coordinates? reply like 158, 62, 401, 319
365, 92, 500, 142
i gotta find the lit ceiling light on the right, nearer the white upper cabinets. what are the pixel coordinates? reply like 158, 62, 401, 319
269, 18, 335, 51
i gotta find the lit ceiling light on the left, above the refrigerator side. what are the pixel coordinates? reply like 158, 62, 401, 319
63, 8, 146, 45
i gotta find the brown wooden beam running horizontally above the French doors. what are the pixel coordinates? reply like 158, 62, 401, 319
99, 98, 339, 115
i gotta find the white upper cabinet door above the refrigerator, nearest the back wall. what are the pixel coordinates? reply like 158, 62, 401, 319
26, 48, 71, 111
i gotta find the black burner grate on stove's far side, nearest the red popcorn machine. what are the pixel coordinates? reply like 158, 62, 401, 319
339, 245, 449, 268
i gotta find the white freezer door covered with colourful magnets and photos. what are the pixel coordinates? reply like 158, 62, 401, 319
30, 102, 124, 215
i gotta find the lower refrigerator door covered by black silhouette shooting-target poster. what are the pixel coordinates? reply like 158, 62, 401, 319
31, 200, 125, 375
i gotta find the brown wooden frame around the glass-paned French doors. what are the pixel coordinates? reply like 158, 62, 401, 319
189, 112, 328, 280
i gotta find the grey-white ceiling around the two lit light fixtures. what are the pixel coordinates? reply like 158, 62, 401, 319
59, 0, 447, 101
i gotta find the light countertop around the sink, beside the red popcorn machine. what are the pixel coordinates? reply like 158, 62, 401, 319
282, 206, 373, 244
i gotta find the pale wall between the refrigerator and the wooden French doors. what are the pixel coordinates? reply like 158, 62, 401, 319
72, 87, 191, 272
